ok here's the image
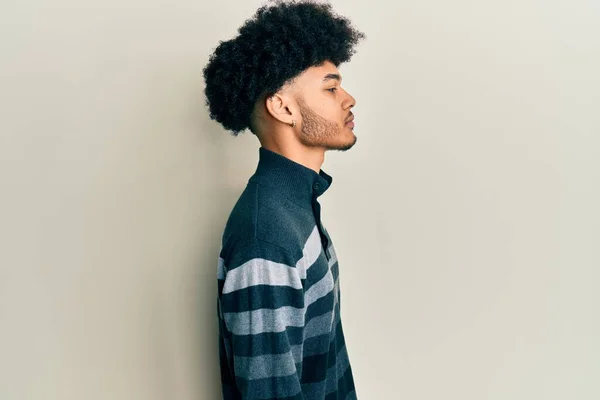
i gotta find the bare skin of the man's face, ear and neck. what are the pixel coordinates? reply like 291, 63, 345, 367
255, 61, 357, 173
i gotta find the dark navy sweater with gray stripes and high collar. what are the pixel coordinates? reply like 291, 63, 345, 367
217, 147, 357, 400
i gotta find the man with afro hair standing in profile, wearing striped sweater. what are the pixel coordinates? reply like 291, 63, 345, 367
204, 1, 365, 400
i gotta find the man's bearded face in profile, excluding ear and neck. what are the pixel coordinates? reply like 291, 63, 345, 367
296, 61, 357, 151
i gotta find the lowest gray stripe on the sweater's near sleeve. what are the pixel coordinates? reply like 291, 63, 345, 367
234, 352, 296, 379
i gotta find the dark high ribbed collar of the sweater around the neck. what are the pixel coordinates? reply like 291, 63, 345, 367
249, 146, 333, 208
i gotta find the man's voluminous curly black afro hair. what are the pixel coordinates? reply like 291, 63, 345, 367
203, 0, 366, 136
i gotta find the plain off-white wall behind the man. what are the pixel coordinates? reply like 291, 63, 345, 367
0, 0, 600, 400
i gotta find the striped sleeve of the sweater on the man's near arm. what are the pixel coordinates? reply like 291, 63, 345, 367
218, 240, 306, 400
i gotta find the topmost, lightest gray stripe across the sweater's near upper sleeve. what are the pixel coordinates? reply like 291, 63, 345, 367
223, 258, 302, 294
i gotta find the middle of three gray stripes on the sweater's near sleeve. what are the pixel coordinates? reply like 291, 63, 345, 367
223, 306, 305, 335
